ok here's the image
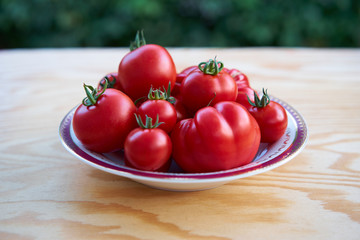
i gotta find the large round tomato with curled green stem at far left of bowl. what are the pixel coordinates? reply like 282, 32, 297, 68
72, 80, 136, 153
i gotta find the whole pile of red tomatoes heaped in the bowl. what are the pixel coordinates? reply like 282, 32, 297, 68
73, 33, 288, 173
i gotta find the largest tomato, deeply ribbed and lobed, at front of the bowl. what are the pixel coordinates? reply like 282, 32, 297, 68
171, 101, 260, 173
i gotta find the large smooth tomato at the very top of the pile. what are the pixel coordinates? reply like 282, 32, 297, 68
118, 30, 176, 101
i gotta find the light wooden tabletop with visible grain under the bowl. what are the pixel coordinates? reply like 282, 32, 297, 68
0, 48, 360, 240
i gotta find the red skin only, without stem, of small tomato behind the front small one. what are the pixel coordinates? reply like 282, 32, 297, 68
137, 100, 177, 133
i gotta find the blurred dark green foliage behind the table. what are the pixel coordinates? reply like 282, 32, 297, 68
0, 0, 360, 48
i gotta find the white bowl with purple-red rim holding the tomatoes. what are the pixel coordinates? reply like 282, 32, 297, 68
59, 97, 308, 191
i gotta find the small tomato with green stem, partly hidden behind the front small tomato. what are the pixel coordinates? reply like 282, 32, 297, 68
137, 84, 177, 133
